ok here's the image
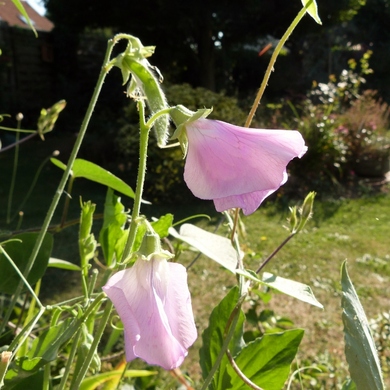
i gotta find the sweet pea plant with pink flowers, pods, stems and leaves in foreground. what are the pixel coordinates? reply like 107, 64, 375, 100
0, 0, 381, 390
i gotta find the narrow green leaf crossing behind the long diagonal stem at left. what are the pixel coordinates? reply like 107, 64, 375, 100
50, 158, 134, 198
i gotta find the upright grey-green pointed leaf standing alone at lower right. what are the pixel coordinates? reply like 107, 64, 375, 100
341, 261, 385, 390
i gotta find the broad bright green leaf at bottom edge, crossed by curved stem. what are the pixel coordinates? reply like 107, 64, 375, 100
227, 329, 304, 390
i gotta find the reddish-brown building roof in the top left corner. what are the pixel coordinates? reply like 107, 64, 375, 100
0, 0, 54, 31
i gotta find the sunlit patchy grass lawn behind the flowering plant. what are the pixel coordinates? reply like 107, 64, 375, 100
185, 195, 390, 389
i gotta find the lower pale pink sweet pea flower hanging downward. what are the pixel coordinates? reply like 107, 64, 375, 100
103, 254, 197, 370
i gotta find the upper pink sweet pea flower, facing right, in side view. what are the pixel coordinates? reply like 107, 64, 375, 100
183, 118, 307, 215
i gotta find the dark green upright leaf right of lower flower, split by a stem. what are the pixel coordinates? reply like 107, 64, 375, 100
199, 286, 245, 389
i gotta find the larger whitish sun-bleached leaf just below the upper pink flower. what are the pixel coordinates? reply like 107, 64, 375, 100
169, 223, 237, 273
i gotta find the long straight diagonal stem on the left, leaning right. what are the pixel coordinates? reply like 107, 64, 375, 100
0, 35, 114, 334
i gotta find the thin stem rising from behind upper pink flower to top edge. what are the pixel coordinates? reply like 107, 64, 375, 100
245, 2, 312, 127
